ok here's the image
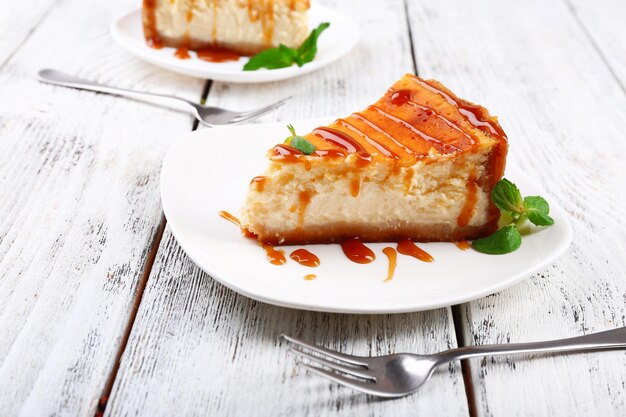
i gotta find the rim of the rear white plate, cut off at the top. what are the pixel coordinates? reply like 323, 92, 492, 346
109, 3, 361, 84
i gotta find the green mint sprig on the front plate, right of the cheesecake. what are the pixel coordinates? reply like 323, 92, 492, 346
472, 178, 554, 255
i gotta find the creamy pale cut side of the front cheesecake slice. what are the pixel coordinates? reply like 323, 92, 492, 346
241, 150, 490, 243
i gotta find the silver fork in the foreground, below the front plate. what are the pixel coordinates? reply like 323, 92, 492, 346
281, 327, 626, 398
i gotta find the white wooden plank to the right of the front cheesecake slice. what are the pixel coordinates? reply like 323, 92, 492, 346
409, 0, 626, 416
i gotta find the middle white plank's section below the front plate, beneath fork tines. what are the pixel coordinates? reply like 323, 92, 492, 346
105, 231, 468, 417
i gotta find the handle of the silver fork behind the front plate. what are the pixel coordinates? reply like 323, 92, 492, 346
37, 68, 195, 111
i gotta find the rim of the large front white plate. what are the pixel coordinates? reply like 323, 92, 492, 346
159, 118, 573, 314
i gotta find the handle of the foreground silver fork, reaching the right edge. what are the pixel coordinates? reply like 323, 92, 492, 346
434, 327, 626, 364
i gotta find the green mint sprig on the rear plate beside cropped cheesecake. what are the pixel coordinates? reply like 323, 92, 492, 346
243, 23, 330, 71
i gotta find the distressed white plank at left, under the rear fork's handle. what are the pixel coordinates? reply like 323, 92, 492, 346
0, 0, 204, 416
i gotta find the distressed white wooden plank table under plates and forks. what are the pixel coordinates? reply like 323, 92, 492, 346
0, 0, 626, 417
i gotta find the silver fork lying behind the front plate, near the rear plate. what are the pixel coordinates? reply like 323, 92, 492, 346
37, 68, 291, 126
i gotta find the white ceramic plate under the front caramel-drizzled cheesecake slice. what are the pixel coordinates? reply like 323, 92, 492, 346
161, 120, 572, 313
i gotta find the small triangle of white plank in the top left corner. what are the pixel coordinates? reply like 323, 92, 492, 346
0, 0, 55, 67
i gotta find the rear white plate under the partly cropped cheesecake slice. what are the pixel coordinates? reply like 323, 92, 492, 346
111, 4, 359, 83
